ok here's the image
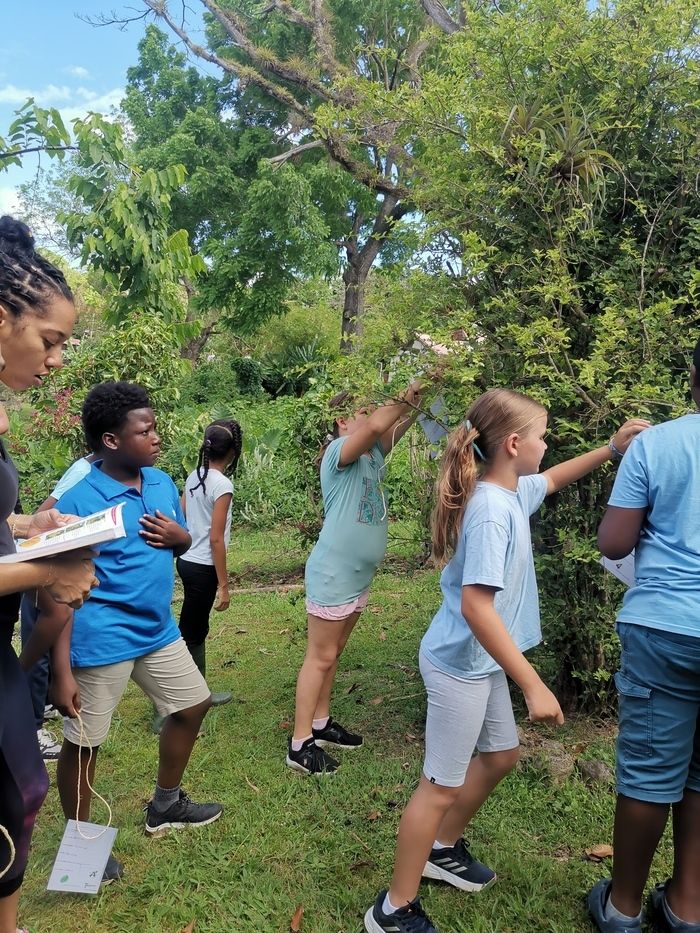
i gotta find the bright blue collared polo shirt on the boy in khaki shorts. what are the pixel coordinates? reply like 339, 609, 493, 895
56, 460, 187, 667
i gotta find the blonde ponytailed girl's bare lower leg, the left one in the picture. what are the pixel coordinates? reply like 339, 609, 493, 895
389, 776, 460, 907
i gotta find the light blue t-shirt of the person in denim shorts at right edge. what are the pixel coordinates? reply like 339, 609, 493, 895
608, 414, 700, 637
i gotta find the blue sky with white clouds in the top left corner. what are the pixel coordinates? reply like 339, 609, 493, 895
0, 0, 145, 214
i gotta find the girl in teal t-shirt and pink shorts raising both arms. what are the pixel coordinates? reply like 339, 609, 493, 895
287, 383, 420, 774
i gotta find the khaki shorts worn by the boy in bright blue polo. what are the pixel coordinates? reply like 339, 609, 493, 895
63, 638, 210, 748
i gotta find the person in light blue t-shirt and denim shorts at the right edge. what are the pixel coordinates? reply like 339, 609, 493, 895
588, 341, 700, 933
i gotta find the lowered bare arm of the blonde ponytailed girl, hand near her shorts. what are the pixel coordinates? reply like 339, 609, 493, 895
462, 584, 564, 725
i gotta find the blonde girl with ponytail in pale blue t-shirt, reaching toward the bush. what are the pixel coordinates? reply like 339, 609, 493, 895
365, 389, 647, 933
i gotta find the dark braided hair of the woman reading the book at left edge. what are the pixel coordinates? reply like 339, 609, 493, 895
0, 214, 73, 317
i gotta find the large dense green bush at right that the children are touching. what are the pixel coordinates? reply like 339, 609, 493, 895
392, 0, 700, 704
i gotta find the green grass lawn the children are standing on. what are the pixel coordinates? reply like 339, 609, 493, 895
20, 530, 670, 933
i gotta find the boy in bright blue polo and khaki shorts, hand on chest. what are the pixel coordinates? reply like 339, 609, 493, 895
56, 382, 222, 860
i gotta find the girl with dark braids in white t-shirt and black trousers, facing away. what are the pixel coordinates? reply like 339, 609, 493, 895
177, 420, 243, 706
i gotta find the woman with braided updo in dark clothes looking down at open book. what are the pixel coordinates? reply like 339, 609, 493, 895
0, 216, 95, 933
